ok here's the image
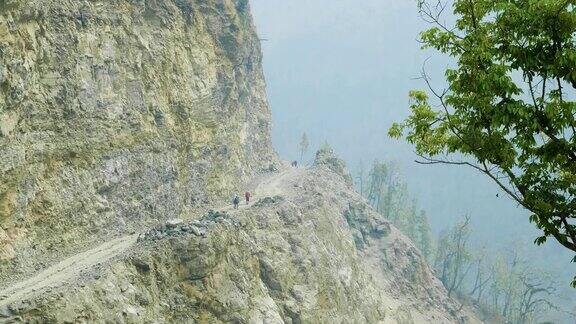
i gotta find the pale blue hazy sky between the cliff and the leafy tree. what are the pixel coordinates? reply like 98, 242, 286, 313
251, 0, 576, 296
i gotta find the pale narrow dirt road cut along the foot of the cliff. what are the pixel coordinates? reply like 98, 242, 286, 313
0, 168, 304, 307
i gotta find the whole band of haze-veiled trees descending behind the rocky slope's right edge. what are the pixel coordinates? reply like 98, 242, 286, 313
355, 161, 576, 324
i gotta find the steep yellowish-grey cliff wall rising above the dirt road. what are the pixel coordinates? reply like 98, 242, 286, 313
0, 0, 276, 281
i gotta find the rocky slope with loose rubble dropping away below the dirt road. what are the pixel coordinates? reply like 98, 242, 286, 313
7, 167, 476, 323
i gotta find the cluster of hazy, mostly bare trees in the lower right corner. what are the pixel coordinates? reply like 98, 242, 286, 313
434, 217, 576, 324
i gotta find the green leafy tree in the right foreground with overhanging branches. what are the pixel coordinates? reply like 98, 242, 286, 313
389, 0, 576, 285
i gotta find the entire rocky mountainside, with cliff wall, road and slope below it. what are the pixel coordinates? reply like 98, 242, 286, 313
0, 0, 482, 323
